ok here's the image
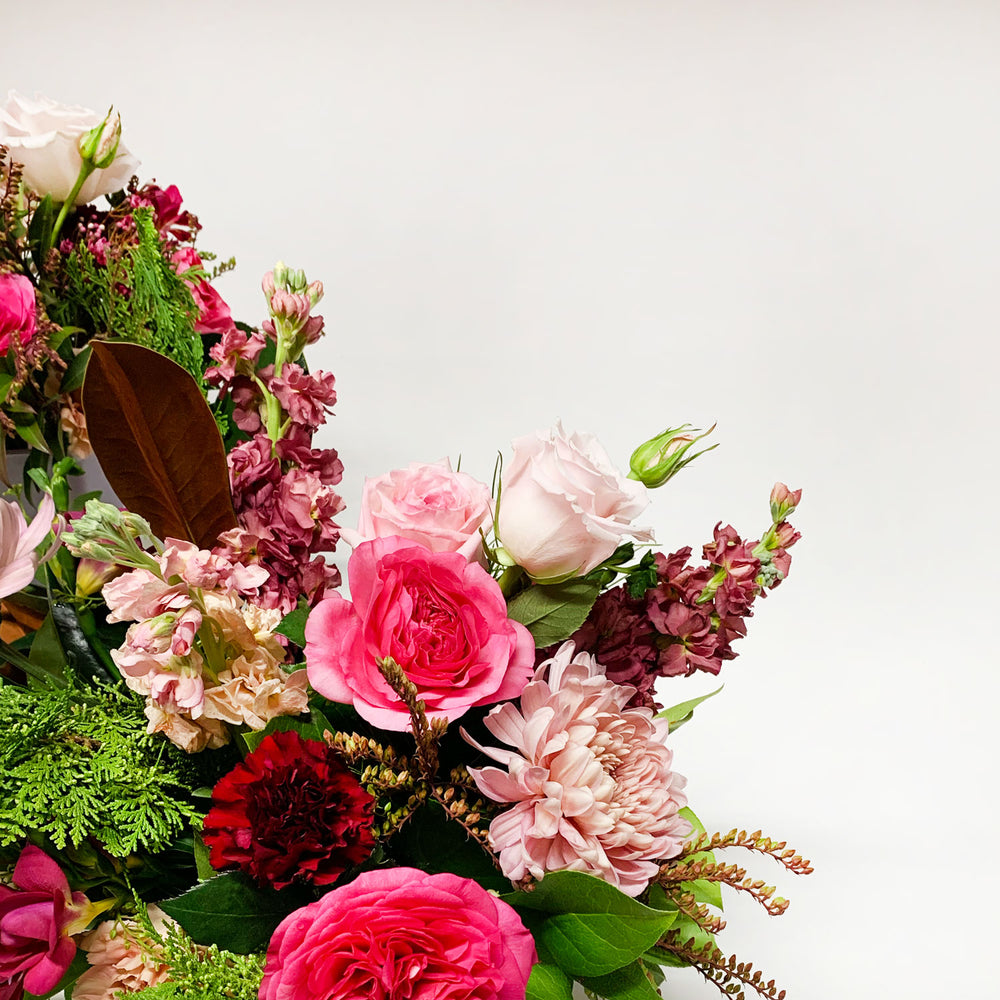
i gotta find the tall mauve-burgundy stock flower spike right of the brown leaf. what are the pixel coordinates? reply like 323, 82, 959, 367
205, 269, 344, 613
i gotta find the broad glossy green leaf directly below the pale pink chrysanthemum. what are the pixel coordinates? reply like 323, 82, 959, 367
501, 871, 676, 976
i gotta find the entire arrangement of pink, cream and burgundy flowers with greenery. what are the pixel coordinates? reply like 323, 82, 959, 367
0, 94, 810, 1000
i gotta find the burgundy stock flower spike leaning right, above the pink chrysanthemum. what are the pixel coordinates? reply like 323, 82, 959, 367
568, 483, 802, 708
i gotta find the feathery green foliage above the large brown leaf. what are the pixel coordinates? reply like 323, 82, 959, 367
52, 208, 203, 382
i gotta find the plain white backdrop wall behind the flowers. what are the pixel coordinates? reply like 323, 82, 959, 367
0, 0, 1000, 1000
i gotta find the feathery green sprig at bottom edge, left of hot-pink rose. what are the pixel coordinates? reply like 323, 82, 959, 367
129, 925, 264, 1000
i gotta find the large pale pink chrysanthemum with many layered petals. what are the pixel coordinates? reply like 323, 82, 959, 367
466, 642, 691, 896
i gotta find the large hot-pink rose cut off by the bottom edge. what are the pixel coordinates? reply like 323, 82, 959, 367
260, 868, 538, 1000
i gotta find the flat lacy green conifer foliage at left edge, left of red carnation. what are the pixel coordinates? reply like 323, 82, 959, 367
0, 685, 201, 858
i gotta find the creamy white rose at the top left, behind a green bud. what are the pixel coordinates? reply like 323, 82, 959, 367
0, 90, 139, 205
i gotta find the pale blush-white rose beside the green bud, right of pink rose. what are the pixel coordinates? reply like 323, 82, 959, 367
497, 423, 653, 583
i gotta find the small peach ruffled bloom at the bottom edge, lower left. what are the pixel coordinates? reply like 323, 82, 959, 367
73, 905, 171, 1000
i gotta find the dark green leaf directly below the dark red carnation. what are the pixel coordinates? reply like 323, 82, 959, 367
159, 872, 312, 955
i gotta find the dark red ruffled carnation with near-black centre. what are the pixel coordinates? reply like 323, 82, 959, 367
204, 732, 375, 889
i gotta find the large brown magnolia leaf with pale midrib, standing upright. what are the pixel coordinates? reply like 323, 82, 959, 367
83, 341, 236, 549
